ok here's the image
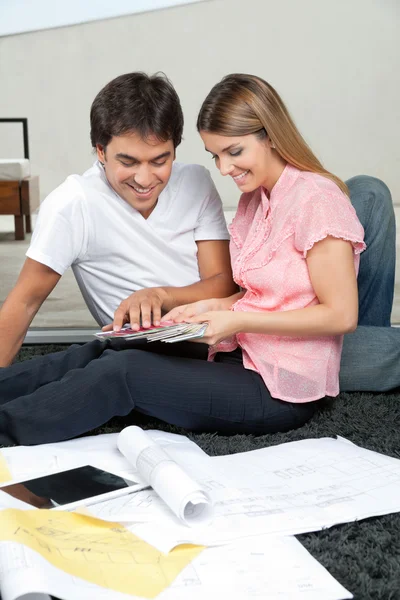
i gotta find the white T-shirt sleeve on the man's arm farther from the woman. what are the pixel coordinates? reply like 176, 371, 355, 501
26, 180, 85, 275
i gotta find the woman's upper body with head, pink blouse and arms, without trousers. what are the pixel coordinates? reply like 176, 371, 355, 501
168, 75, 365, 402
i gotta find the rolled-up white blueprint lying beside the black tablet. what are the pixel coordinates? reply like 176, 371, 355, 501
117, 426, 212, 526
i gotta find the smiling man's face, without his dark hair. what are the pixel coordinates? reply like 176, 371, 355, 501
96, 133, 175, 219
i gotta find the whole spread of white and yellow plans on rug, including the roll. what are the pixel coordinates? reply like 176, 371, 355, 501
6, 427, 400, 600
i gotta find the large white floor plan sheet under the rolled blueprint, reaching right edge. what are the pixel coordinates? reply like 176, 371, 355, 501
89, 438, 400, 552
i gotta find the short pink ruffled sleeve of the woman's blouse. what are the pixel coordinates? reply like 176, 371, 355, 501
294, 192, 366, 258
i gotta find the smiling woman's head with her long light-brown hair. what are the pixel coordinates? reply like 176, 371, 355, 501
197, 74, 348, 194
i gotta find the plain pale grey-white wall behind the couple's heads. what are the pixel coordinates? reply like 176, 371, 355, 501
0, 0, 400, 206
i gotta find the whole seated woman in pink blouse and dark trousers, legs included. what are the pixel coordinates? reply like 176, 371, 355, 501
0, 75, 365, 444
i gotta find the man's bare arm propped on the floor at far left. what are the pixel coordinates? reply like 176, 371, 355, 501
0, 258, 61, 367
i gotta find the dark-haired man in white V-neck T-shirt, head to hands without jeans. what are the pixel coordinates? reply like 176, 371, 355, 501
0, 73, 236, 367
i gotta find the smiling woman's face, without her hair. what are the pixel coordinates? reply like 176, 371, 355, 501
200, 131, 286, 192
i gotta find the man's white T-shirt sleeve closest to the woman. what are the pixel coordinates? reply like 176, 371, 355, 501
194, 169, 229, 241
